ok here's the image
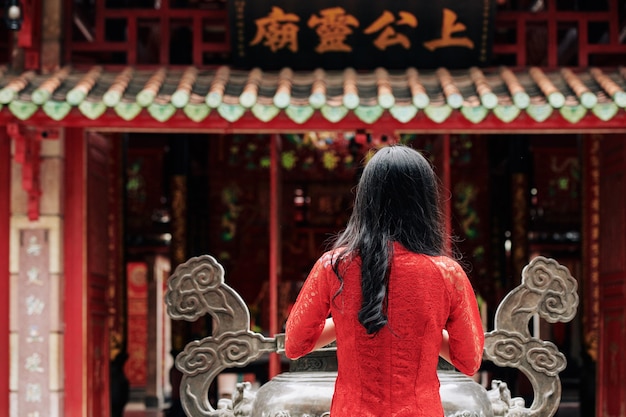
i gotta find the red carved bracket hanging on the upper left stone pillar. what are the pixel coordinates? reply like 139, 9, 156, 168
7, 123, 41, 221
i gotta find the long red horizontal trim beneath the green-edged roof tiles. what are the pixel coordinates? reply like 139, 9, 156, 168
0, 109, 626, 134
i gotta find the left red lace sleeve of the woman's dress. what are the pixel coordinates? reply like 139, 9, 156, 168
285, 255, 332, 359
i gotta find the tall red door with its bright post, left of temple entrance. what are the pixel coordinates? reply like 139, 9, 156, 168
64, 129, 111, 417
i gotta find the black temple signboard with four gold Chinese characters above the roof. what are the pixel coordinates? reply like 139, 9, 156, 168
229, 0, 495, 70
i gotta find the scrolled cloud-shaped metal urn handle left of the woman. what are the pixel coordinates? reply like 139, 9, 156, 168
165, 255, 276, 417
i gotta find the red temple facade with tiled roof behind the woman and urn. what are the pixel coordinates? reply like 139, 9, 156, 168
0, 0, 626, 417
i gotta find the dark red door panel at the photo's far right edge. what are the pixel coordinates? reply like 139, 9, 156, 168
596, 135, 626, 417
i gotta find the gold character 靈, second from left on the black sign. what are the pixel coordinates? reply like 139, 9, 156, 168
308, 7, 359, 54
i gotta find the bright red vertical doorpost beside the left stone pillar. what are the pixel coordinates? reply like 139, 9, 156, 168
63, 129, 87, 417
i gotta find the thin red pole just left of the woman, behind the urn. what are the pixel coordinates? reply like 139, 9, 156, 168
269, 134, 281, 378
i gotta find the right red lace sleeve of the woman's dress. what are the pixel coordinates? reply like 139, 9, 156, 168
437, 258, 485, 375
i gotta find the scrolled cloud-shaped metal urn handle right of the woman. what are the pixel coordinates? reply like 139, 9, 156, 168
483, 256, 579, 417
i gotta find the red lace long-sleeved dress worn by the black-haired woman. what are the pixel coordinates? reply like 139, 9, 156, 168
285, 243, 484, 417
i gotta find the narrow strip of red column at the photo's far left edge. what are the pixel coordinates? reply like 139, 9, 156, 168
0, 123, 11, 415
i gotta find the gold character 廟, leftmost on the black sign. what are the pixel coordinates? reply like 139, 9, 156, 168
250, 6, 300, 52
